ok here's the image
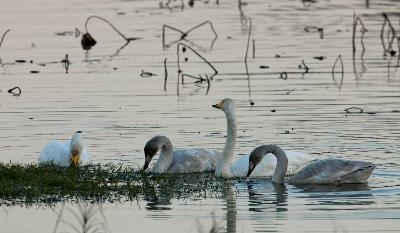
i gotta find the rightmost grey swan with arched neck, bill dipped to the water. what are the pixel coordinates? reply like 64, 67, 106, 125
247, 145, 376, 184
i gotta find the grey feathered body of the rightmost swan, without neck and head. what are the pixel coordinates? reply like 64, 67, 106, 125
289, 159, 375, 184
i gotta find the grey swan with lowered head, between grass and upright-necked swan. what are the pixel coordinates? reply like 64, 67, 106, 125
143, 136, 221, 173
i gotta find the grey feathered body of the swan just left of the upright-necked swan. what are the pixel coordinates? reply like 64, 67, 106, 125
168, 149, 222, 173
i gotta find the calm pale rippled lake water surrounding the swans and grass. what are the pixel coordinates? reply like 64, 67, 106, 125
0, 0, 400, 233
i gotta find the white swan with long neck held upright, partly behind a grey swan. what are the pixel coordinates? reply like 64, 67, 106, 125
213, 98, 312, 177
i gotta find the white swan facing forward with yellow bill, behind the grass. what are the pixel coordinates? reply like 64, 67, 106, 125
38, 131, 90, 166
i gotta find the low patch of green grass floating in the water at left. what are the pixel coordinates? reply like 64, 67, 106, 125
0, 163, 231, 205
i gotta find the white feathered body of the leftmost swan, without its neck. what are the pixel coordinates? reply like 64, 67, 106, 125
38, 140, 69, 166
